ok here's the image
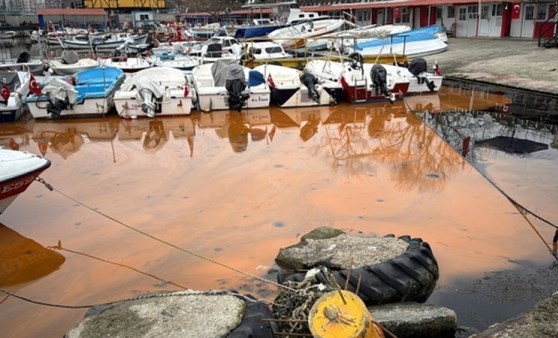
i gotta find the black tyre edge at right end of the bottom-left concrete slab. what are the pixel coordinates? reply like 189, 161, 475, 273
227, 300, 277, 338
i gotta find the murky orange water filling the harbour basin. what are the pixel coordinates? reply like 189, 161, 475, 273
0, 91, 558, 337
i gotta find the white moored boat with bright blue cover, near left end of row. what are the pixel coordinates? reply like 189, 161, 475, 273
26, 66, 125, 119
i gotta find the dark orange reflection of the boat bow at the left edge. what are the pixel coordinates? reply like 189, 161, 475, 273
0, 224, 66, 287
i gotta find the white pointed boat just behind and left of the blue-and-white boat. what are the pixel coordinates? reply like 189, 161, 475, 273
267, 19, 346, 49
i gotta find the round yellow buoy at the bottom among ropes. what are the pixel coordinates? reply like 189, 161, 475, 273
308, 290, 384, 338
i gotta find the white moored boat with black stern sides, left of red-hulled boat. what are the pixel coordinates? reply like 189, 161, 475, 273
254, 64, 343, 107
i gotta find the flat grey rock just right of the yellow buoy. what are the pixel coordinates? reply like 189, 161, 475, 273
368, 302, 457, 338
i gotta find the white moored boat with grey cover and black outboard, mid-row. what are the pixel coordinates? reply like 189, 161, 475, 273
189, 59, 270, 112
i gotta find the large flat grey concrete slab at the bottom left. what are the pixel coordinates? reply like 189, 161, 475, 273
65, 291, 271, 338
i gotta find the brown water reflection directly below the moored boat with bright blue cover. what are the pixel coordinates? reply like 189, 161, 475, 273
33, 118, 118, 159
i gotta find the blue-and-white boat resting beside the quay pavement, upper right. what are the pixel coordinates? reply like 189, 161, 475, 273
345, 25, 448, 57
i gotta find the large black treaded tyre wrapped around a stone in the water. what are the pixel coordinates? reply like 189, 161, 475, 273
277, 236, 439, 305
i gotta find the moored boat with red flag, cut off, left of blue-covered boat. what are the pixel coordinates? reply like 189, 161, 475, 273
0, 70, 31, 122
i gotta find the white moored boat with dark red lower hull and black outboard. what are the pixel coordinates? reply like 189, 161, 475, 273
305, 60, 410, 103
